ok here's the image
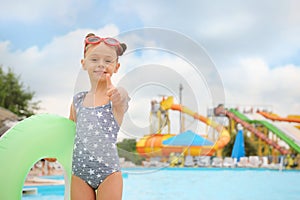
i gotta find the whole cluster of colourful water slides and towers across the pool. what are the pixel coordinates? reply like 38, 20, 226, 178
136, 94, 300, 166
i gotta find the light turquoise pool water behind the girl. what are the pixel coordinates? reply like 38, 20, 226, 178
23, 168, 300, 200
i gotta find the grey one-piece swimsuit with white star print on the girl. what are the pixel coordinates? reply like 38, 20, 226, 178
72, 92, 120, 190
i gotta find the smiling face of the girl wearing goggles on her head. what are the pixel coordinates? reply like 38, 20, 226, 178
81, 42, 120, 82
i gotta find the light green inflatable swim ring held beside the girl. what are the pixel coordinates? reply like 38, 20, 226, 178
0, 114, 75, 199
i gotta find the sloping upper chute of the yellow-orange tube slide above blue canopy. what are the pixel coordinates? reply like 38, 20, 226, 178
161, 97, 230, 150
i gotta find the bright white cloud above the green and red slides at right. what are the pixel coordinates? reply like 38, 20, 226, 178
221, 58, 300, 115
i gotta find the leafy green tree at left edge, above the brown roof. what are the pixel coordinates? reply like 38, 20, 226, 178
0, 65, 40, 117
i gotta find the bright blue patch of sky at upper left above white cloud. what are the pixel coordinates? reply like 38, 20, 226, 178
0, 0, 143, 50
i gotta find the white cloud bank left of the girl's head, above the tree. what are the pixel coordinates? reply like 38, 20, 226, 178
0, 25, 119, 116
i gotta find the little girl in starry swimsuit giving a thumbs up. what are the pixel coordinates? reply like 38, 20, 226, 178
70, 33, 129, 200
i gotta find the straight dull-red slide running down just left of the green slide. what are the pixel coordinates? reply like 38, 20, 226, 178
215, 107, 290, 154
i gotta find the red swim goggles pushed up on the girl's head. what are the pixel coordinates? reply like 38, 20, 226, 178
84, 36, 123, 55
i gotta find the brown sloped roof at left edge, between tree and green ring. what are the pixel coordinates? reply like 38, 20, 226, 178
0, 107, 20, 137
